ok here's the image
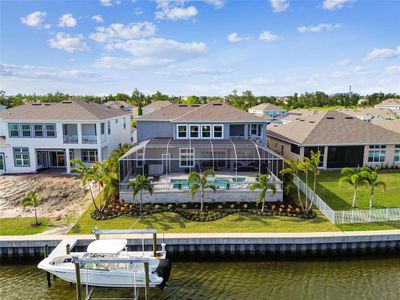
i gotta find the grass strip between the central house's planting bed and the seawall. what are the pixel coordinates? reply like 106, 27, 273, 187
69, 207, 339, 234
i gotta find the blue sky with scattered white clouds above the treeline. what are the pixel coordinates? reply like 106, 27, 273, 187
0, 0, 400, 96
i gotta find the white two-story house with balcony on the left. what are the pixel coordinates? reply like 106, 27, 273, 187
0, 100, 131, 173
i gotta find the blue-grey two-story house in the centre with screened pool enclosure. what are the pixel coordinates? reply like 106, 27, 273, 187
120, 101, 283, 202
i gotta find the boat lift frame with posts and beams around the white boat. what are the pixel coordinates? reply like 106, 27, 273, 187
72, 228, 161, 300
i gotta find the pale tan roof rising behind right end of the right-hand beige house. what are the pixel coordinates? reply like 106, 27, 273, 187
337, 107, 398, 122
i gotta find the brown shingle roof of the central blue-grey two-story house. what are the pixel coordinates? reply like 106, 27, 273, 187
138, 101, 266, 123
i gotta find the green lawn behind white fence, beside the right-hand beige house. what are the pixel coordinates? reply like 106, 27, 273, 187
309, 170, 400, 210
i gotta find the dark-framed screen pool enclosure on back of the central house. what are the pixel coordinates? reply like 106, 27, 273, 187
119, 139, 283, 191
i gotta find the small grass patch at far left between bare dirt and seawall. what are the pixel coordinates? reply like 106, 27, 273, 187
0, 218, 49, 235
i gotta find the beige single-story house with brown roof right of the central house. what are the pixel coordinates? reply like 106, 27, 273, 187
267, 111, 400, 169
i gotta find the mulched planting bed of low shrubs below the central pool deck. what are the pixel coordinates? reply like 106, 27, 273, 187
91, 201, 316, 222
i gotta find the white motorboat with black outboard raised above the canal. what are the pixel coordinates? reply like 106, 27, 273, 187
38, 239, 171, 289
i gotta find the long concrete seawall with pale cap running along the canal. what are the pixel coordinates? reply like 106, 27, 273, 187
0, 230, 400, 260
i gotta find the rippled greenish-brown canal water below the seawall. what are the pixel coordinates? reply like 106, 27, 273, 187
0, 257, 400, 300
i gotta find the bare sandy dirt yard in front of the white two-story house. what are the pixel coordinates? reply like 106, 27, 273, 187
0, 173, 86, 220
